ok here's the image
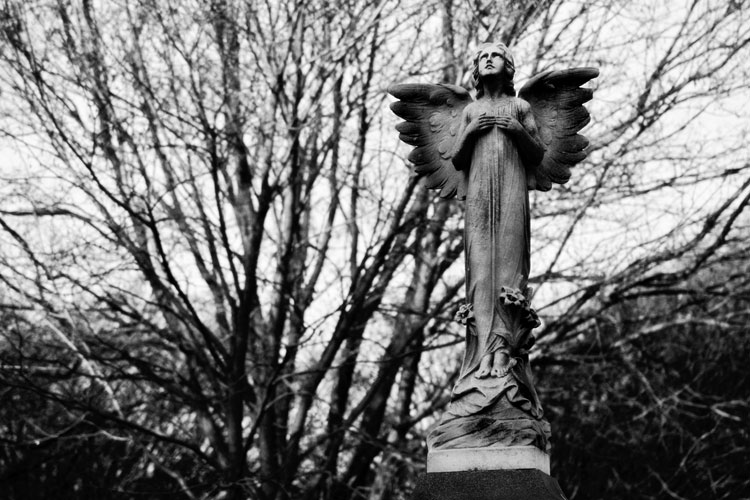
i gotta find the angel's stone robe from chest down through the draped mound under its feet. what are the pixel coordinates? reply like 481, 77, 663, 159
428, 97, 549, 451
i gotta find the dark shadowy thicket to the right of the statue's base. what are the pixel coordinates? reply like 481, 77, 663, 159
541, 280, 750, 500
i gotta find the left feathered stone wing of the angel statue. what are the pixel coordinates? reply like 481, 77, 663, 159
388, 83, 472, 200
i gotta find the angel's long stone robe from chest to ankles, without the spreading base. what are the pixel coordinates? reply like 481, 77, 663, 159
462, 97, 533, 376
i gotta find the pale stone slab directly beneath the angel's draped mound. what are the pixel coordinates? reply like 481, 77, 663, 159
427, 446, 549, 474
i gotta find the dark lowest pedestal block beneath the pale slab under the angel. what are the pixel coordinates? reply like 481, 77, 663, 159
412, 469, 567, 500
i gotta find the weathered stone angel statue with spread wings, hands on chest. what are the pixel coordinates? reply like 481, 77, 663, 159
388, 43, 599, 456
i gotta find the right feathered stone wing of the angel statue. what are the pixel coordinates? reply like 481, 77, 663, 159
518, 68, 599, 191
